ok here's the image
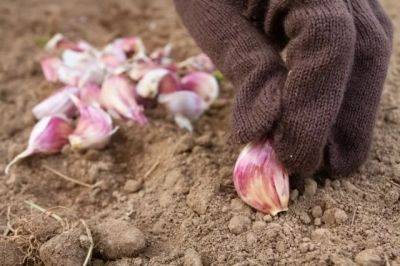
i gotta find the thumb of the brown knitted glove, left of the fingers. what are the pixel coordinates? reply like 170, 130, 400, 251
175, 0, 287, 143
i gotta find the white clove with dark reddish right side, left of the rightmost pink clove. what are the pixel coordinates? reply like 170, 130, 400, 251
136, 68, 180, 98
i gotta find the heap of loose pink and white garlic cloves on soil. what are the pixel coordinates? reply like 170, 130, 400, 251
6, 33, 219, 173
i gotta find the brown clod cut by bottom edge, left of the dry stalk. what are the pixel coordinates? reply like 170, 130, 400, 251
39, 228, 87, 266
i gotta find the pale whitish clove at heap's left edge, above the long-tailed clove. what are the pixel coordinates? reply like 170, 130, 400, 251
32, 86, 79, 119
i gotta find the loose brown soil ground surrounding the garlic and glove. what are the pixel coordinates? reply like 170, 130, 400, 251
0, 0, 400, 266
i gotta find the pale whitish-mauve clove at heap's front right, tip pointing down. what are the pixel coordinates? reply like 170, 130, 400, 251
158, 91, 207, 131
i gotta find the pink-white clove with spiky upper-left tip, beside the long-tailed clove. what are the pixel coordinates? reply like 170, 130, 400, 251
68, 95, 118, 150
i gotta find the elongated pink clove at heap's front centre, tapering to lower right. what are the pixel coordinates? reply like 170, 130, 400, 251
100, 75, 148, 125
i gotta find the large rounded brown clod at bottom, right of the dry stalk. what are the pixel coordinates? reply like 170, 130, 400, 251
93, 219, 146, 259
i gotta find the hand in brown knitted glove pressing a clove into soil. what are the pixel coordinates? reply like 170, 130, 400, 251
174, 0, 393, 174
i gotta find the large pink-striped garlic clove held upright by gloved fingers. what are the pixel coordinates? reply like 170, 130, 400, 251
233, 141, 289, 215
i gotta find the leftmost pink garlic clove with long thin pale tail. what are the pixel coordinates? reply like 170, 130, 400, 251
5, 115, 73, 174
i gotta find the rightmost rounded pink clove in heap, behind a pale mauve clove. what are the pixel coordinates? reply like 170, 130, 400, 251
181, 72, 219, 106
